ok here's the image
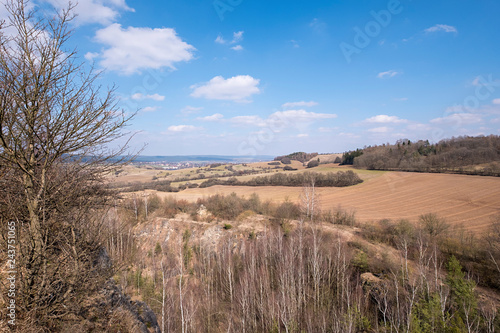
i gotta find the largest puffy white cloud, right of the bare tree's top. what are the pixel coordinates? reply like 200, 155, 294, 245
95, 23, 196, 75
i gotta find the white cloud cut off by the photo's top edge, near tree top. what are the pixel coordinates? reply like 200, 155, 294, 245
46, 0, 134, 25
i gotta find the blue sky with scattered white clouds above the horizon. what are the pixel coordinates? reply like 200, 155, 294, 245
17, 0, 500, 155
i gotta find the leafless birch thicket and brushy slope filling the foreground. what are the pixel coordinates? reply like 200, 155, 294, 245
109, 195, 500, 332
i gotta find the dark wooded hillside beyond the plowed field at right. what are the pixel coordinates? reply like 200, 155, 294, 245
343, 135, 500, 176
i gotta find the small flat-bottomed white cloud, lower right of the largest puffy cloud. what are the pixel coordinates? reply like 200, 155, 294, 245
191, 75, 260, 102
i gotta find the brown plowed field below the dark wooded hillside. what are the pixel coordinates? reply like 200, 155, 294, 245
162, 172, 500, 232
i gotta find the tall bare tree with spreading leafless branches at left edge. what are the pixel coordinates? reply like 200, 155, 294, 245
0, 0, 134, 326
